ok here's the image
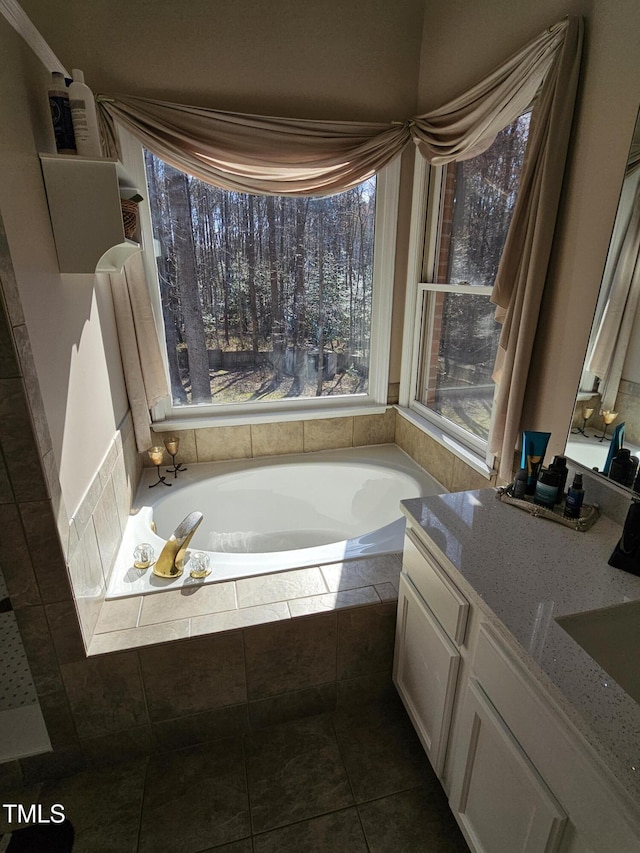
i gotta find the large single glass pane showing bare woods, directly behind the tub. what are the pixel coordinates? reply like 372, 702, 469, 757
145, 152, 376, 406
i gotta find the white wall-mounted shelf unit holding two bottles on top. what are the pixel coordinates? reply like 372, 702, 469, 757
40, 154, 142, 274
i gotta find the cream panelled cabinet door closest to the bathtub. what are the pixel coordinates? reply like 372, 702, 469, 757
393, 574, 460, 776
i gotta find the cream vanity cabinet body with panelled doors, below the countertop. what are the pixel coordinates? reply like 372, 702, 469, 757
394, 527, 640, 853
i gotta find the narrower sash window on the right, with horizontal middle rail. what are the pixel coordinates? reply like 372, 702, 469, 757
409, 114, 529, 453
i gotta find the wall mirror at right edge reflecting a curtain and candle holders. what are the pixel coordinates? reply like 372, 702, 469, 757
565, 108, 640, 486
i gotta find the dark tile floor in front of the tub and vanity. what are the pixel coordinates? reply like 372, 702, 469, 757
0, 697, 467, 853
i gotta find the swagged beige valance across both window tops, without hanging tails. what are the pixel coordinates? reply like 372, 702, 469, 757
98, 19, 575, 196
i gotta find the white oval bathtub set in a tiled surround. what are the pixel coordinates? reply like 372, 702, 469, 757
106, 445, 446, 598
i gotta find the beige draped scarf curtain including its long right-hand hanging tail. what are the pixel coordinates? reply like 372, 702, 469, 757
97, 17, 582, 479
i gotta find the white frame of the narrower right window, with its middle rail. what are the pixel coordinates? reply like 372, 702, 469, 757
398, 151, 494, 470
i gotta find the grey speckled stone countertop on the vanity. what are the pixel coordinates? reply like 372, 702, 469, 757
402, 489, 640, 802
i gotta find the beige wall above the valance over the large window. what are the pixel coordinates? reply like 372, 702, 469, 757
22, 0, 424, 121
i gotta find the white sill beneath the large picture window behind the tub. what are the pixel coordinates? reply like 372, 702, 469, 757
152, 402, 390, 432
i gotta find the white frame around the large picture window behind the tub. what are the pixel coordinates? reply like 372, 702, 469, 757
118, 128, 401, 429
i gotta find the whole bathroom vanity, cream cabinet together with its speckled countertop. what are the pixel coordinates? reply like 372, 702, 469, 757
394, 489, 640, 853
